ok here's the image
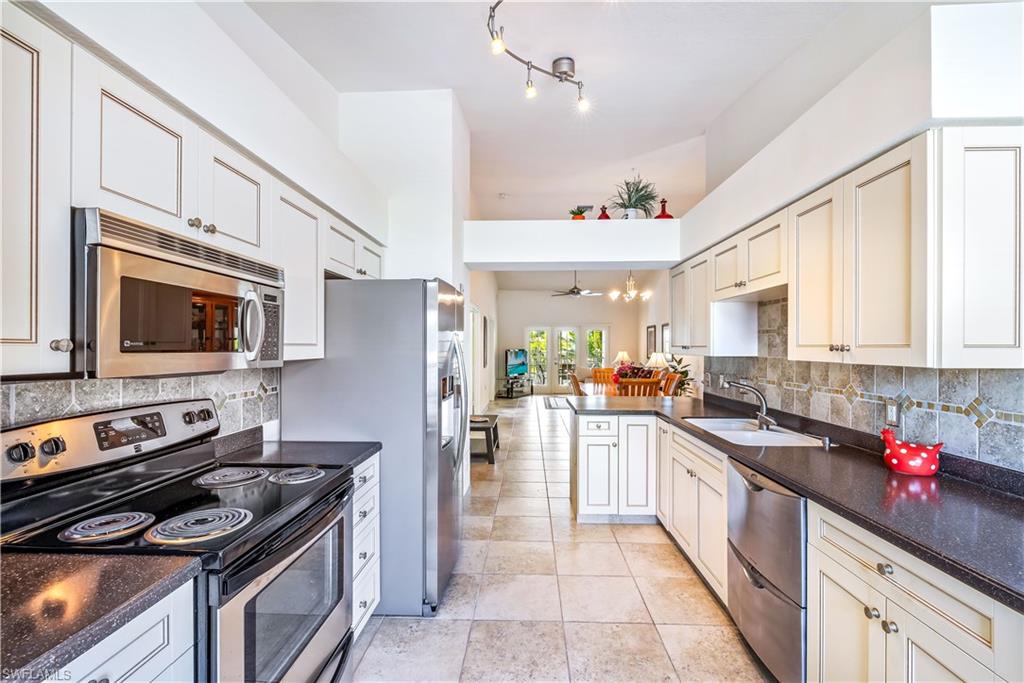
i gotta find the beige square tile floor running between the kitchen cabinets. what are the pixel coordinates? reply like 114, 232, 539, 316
353, 397, 764, 681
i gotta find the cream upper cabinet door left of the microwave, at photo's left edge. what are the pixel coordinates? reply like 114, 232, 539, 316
0, 3, 72, 379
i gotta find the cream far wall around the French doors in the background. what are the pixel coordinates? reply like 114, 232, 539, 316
495, 290, 639, 389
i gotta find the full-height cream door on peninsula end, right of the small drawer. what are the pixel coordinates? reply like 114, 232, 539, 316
618, 416, 657, 515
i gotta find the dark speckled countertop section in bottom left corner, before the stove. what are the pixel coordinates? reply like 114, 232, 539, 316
0, 552, 202, 681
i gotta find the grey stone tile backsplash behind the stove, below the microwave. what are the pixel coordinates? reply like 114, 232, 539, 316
0, 368, 281, 434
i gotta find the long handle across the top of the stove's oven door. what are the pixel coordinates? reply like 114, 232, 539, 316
217, 483, 353, 606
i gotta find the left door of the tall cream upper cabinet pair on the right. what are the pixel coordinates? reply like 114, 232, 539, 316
787, 181, 843, 360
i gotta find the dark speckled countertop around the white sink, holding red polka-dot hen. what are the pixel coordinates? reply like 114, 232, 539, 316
568, 396, 1024, 612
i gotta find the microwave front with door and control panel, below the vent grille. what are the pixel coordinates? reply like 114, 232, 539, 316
86, 246, 281, 377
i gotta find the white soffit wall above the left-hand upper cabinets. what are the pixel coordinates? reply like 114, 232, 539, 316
37, 2, 388, 243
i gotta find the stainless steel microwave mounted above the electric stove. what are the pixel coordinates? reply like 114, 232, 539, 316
73, 209, 285, 378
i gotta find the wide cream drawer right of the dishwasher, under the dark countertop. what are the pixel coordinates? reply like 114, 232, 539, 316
808, 503, 1024, 680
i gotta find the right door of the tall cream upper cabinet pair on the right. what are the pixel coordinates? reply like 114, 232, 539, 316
842, 133, 934, 367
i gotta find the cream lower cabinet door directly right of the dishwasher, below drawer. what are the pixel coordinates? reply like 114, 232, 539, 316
807, 547, 886, 683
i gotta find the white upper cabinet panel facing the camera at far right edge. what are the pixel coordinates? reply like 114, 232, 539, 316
939, 127, 1024, 368
